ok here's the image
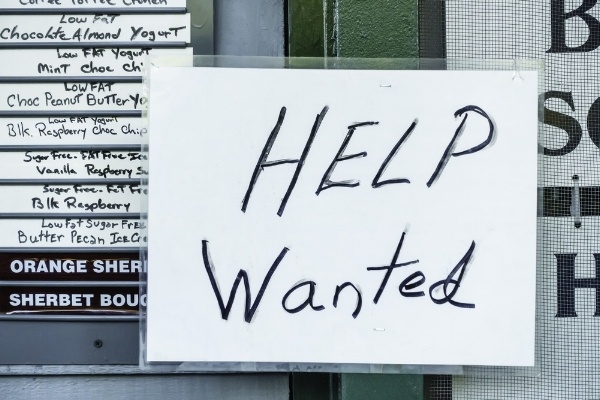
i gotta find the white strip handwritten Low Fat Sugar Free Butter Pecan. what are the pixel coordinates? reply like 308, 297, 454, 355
0, 218, 147, 247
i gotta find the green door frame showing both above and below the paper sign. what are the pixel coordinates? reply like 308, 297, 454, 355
286, 0, 428, 400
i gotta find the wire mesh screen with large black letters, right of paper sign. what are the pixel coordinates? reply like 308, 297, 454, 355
419, 0, 600, 400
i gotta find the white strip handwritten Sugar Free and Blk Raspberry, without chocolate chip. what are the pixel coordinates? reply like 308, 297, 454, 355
0, 183, 146, 214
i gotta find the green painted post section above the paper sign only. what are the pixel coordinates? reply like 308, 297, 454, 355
287, 0, 419, 58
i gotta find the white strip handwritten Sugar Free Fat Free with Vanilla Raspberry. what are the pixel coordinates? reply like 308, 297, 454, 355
0, 150, 148, 180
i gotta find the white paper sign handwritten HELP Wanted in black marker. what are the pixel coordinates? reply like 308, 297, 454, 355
147, 68, 538, 366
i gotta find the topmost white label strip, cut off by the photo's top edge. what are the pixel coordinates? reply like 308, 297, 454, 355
0, 0, 185, 11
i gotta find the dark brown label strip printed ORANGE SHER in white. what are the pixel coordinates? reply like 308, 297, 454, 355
0, 251, 141, 282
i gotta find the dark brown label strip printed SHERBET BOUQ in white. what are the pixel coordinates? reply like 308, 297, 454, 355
0, 286, 141, 315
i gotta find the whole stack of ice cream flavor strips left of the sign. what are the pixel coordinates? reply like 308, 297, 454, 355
0, 0, 192, 318
